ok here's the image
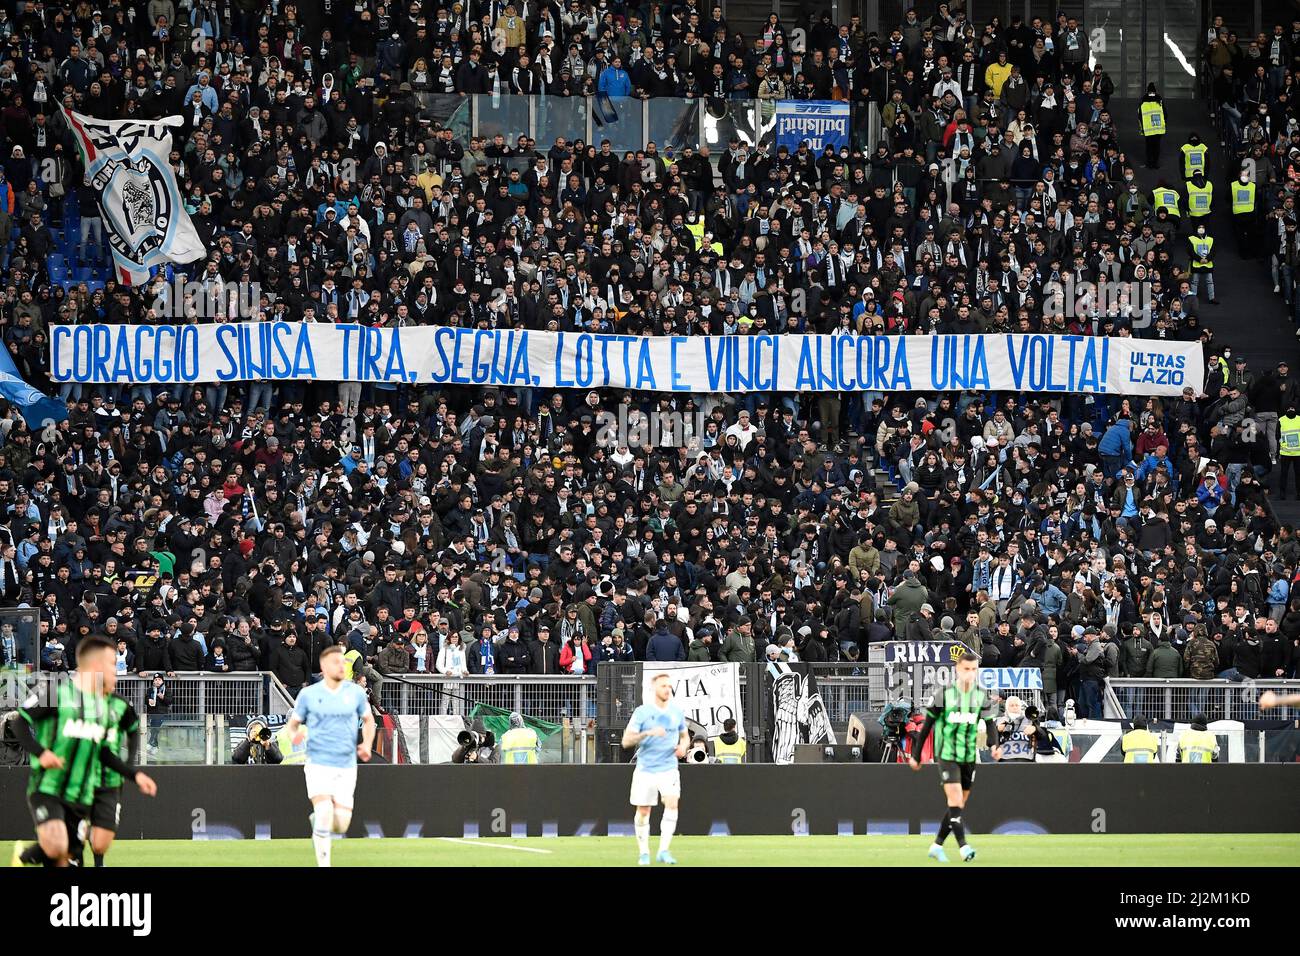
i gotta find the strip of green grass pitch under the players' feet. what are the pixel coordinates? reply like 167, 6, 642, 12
78, 834, 1300, 869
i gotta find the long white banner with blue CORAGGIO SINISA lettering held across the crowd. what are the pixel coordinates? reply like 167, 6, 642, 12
49, 323, 1205, 395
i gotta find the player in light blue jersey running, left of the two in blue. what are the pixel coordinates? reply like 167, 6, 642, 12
289, 644, 374, 866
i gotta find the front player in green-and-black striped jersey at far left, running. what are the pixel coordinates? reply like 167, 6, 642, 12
12, 636, 157, 866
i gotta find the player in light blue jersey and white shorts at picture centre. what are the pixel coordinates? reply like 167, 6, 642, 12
623, 674, 690, 866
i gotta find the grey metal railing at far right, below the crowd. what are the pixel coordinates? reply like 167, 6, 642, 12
1105, 678, 1300, 721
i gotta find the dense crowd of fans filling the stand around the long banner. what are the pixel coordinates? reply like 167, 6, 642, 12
0, 0, 1300, 715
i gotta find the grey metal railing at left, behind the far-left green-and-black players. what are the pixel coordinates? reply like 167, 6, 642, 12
27, 671, 294, 717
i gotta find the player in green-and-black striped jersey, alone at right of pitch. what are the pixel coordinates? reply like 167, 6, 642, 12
907, 652, 1002, 862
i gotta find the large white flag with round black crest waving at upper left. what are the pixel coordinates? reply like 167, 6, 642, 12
60, 107, 207, 285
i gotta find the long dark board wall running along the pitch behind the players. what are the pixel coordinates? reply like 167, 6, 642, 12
0, 763, 1300, 839
